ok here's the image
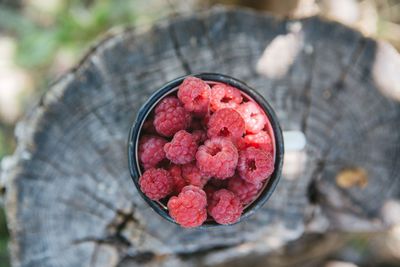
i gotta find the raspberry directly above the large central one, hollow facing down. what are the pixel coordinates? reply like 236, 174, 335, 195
207, 108, 245, 143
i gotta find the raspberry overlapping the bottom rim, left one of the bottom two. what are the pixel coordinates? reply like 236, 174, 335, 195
167, 185, 207, 228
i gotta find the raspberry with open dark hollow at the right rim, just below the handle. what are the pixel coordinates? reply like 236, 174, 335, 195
237, 147, 274, 184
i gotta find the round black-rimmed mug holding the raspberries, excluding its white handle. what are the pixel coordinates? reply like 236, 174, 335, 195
128, 73, 284, 228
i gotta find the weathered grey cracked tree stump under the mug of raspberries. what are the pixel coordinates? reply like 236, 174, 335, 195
2, 8, 400, 267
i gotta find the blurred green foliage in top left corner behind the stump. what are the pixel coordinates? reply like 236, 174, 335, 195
0, 0, 143, 69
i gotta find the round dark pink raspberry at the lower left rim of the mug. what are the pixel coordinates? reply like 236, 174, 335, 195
139, 168, 174, 200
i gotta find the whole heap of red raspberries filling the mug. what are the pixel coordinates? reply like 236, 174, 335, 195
139, 77, 274, 228
